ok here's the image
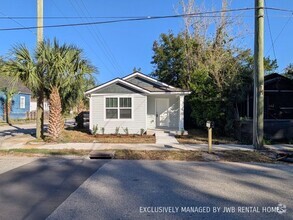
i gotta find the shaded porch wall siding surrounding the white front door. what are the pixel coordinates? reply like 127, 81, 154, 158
147, 95, 180, 129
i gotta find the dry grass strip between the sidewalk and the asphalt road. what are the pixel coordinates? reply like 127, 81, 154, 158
0, 148, 279, 163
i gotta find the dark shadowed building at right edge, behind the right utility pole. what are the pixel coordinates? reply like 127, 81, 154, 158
239, 73, 293, 141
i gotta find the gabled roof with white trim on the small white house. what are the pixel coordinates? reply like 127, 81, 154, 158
85, 72, 190, 95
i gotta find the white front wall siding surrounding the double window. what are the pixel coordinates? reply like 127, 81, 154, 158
90, 93, 147, 134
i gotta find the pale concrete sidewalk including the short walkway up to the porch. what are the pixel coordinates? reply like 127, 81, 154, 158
0, 130, 293, 151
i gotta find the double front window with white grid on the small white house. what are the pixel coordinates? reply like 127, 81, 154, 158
106, 98, 132, 119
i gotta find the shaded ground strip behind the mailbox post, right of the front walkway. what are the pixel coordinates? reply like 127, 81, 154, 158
175, 129, 239, 144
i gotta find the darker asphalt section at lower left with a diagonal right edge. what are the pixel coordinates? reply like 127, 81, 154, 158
0, 157, 107, 220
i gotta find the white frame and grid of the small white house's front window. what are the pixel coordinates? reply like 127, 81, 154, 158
104, 95, 134, 121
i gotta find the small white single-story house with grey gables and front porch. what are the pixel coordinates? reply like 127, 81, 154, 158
85, 72, 191, 134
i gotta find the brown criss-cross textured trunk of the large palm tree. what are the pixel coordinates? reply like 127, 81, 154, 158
48, 87, 64, 140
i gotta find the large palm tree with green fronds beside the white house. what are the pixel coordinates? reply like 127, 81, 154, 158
38, 40, 95, 140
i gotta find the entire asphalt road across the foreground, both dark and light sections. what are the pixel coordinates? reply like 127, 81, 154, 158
0, 157, 293, 220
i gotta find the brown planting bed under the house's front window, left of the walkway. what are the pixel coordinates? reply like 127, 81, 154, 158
45, 130, 156, 144
